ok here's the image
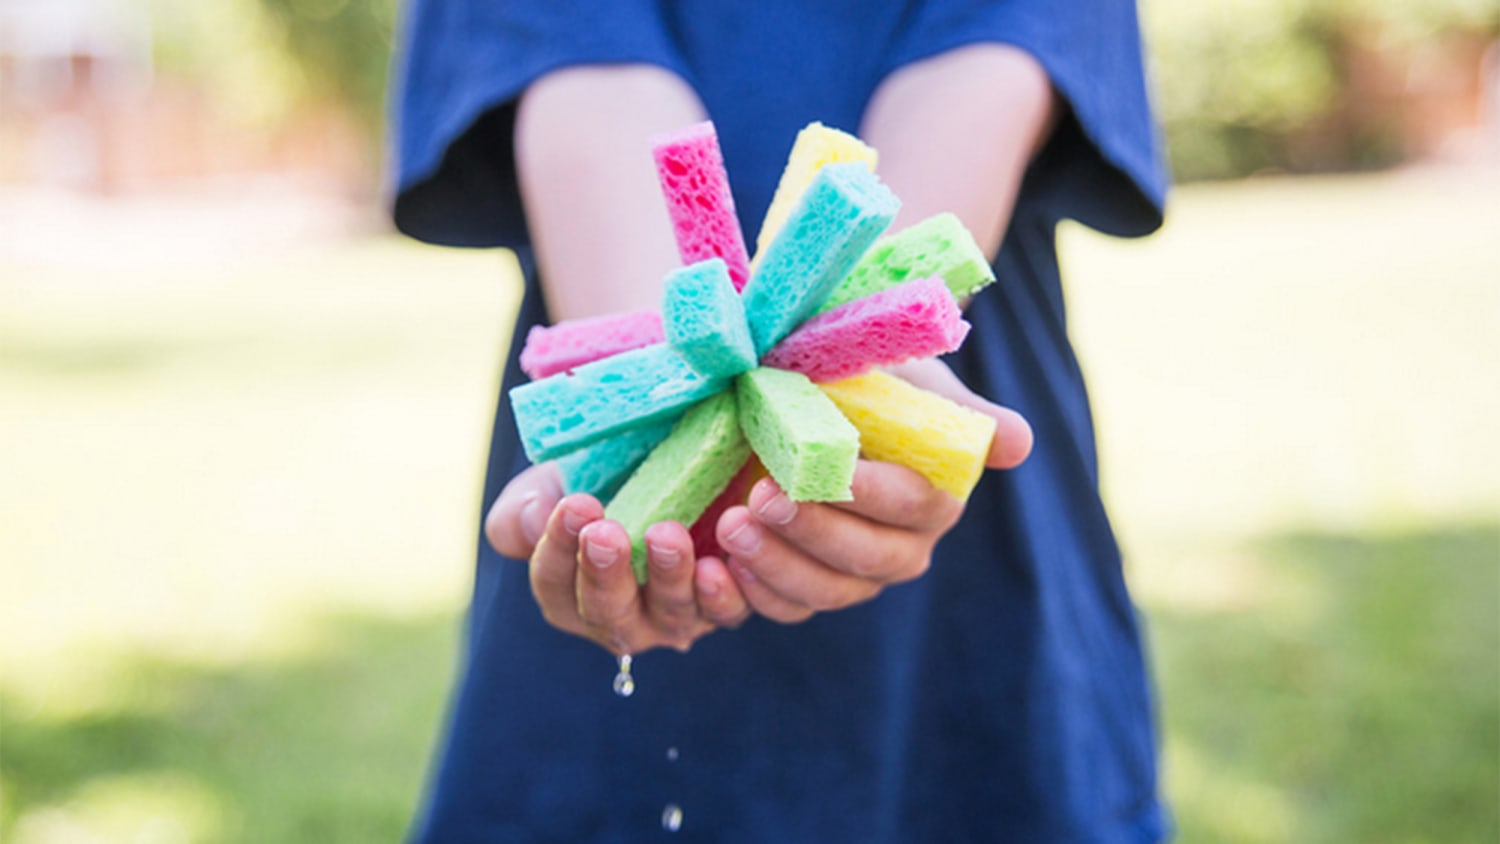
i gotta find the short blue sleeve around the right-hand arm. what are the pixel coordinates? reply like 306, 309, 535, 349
890, 0, 1167, 237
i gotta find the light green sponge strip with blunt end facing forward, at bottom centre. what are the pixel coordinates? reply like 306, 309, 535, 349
735, 366, 860, 501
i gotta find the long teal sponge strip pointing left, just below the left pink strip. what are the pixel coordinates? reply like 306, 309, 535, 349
510, 343, 726, 463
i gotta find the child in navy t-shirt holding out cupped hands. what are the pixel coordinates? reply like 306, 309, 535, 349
395, 0, 1167, 843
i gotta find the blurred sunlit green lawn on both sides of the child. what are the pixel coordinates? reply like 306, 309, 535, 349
0, 175, 1500, 844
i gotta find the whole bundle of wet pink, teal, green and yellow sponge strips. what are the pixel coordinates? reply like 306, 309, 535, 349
510, 123, 995, 582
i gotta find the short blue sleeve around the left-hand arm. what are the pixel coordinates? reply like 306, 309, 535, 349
392, 0, 687, 247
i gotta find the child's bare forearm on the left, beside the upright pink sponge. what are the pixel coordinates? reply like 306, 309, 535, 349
516, 64, 704, 319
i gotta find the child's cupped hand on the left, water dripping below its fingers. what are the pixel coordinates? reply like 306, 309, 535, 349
485, 463, 750, 655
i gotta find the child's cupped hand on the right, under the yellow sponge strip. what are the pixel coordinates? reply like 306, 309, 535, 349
717, 361, 1032, 622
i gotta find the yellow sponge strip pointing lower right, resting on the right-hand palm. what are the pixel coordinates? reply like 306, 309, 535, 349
819, 370, 995, 501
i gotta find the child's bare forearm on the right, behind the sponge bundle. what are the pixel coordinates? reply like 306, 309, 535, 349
860, 43, 1059, 258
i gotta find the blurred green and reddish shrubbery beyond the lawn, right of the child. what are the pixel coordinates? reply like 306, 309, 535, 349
1143, 0, 1500, 180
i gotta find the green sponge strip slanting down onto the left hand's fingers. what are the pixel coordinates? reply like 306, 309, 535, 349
605, 391, 750, 583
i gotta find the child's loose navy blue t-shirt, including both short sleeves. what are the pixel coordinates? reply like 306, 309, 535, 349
395, 0, 1167, 843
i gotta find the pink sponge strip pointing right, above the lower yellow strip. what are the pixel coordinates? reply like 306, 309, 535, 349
762, 277, 969, 382
